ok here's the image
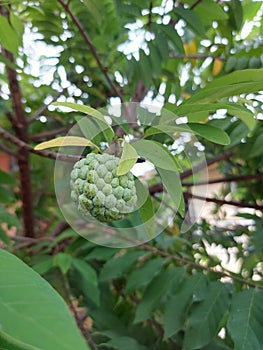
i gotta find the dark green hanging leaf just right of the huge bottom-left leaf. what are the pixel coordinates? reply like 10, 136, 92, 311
72, 258, 100, 305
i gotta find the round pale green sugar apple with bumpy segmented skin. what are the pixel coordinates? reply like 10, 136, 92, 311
70, 153, 137, 222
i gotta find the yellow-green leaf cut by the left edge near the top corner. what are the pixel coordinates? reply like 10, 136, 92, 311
0, 15, 20, 56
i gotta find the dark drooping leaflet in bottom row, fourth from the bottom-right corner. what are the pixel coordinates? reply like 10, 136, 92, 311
134, 267, 185, 323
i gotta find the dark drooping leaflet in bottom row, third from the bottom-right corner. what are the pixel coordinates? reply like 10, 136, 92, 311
164, 273, 207, 340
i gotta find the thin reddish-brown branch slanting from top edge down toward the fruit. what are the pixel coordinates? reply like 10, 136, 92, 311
58, 0, 123, 102
